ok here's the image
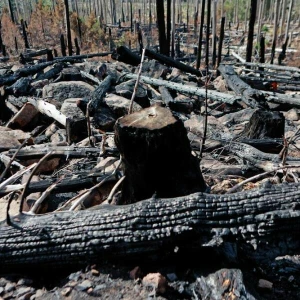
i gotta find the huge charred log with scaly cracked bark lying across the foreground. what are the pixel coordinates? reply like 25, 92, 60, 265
0, 180, 300, 271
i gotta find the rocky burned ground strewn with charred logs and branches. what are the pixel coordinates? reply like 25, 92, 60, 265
0, 47, 300, 300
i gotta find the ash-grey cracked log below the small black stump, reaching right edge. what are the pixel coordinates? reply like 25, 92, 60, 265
224, 142, 300, 172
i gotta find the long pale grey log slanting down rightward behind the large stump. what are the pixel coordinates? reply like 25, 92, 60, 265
124, 74, 241, 105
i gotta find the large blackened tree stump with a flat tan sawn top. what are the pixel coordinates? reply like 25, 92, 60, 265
115, 106, 206, 203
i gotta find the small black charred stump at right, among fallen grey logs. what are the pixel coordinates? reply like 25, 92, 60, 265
241, 109, 285, 139
